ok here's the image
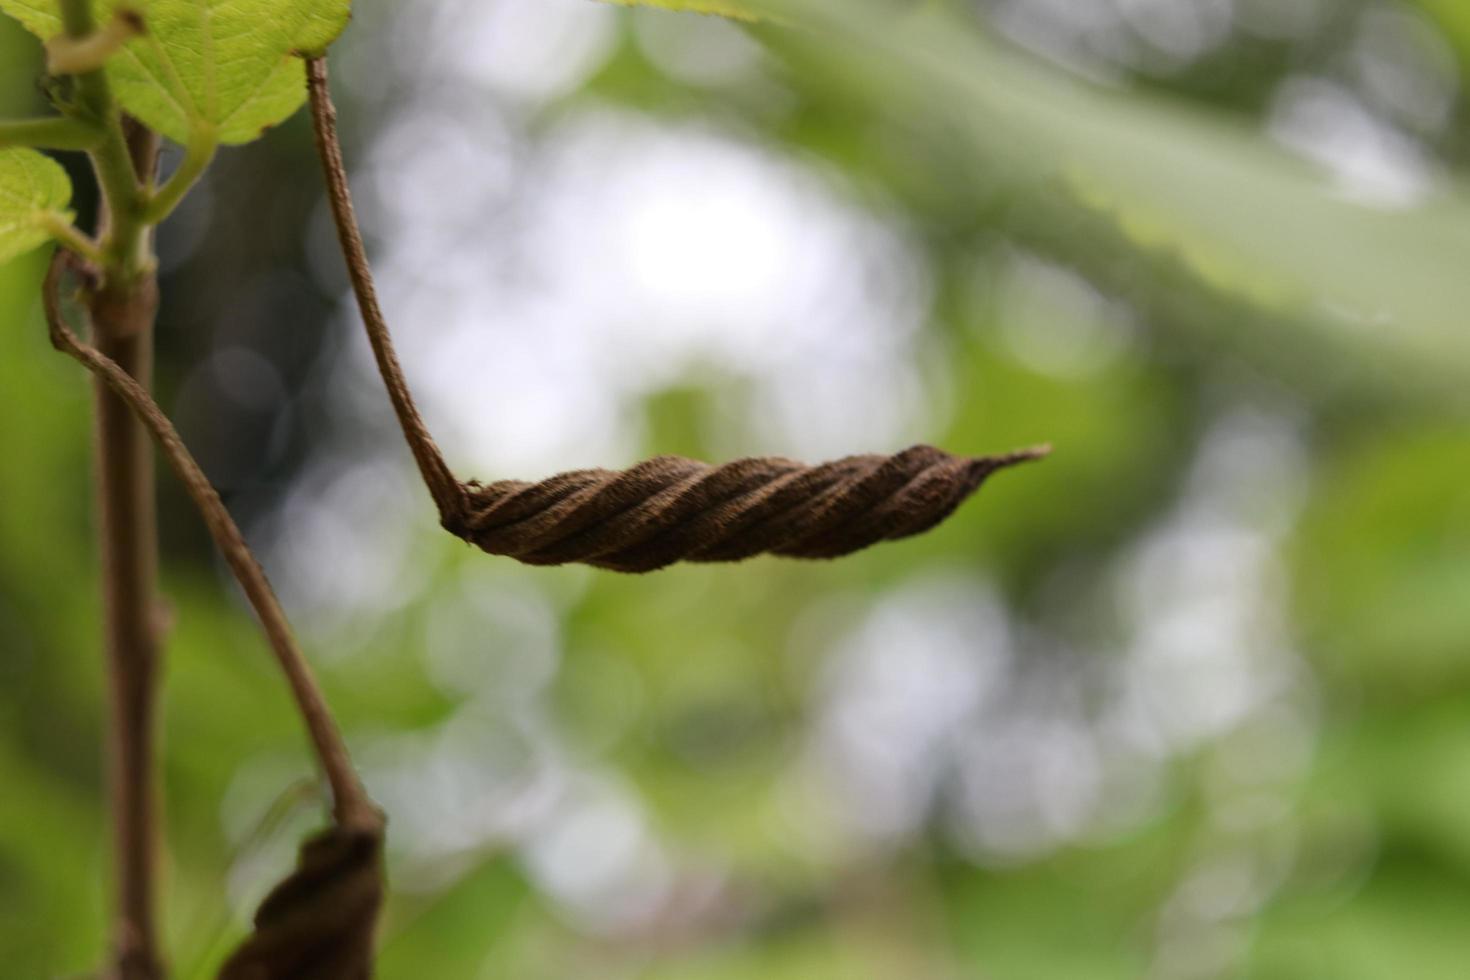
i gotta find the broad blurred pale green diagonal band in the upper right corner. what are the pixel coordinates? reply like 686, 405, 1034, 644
781, 0, 1470, 379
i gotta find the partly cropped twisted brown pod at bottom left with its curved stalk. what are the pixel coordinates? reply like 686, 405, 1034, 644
43, 253, 384, 980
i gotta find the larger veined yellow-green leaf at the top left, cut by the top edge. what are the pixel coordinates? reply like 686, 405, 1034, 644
0, 0, 351, 143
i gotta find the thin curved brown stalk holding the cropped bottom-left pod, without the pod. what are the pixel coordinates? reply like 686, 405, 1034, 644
43, 251, 382, 829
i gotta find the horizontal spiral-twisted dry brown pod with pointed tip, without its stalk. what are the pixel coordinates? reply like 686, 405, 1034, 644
450, 445, 1047, 572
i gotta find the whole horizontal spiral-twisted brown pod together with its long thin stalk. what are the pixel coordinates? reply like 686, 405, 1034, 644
307, 57, 1050, 572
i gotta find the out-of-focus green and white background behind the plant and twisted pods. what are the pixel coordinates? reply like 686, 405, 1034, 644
0, 0, 1470, 980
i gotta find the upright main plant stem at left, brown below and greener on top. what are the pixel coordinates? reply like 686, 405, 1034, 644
60, 0, 165, 980
